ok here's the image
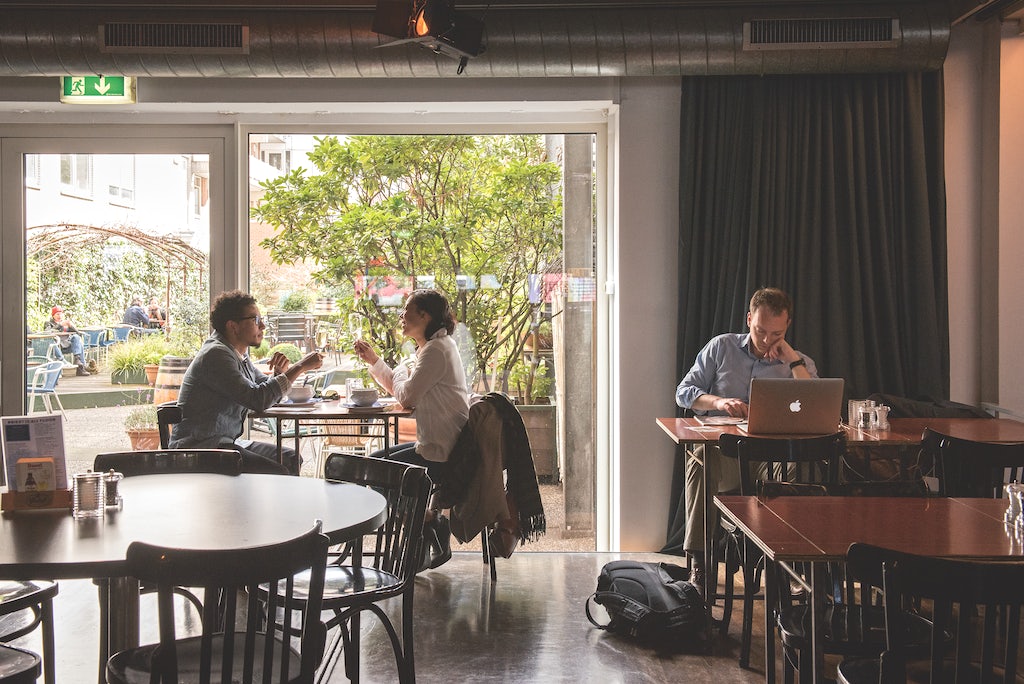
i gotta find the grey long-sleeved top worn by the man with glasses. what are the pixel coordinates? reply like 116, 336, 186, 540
168, 332, 291, 448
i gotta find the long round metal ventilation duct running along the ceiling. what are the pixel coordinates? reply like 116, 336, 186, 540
0, 2, 949, 78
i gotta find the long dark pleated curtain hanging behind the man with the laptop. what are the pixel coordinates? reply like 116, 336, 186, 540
667, 72, 949, 550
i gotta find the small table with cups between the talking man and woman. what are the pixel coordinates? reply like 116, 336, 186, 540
252, 398, 413, 461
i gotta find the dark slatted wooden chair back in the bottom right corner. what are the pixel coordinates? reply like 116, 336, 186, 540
847, 544, 1024, 682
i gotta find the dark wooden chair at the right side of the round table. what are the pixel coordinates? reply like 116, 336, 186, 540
283, 454, 430, 682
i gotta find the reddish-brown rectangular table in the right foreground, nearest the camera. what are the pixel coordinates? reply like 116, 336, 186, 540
715, 495, 1024, 682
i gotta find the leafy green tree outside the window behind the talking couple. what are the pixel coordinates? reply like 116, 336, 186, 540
252, 135, 562, 391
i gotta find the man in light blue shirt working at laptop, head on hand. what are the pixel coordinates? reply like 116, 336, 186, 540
676, 288, 818, 593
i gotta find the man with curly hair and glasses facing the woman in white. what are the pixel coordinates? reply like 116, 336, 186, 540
168, 290, 324, 475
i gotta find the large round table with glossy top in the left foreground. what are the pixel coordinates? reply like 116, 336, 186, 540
0, 473, 386, 679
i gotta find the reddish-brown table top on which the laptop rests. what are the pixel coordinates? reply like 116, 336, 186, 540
656, 418, 1024, 446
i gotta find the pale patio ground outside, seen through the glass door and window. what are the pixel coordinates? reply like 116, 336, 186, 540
65, 405, 596, 551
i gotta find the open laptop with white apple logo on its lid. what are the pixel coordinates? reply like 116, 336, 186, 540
746, 378, 843, 434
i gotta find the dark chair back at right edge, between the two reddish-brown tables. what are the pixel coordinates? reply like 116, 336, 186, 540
921, 428, 1024, 499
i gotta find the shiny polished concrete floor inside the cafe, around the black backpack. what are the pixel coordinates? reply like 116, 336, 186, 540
4, 552, 794, 684
